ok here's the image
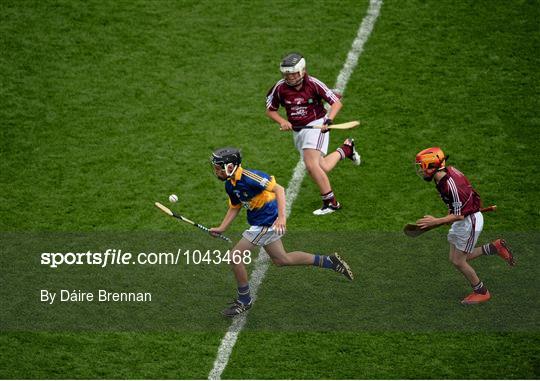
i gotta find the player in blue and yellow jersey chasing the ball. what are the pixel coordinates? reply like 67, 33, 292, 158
210, 148, 353, 317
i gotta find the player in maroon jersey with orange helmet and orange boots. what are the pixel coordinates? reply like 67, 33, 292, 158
416, 147, 515, 304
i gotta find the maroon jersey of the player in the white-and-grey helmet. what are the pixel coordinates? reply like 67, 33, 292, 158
266, 74, 339, 126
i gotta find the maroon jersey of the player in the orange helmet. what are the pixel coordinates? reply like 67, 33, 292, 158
437, 167, 481, 216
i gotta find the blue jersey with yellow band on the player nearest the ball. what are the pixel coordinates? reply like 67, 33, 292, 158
225, 167, 278, 226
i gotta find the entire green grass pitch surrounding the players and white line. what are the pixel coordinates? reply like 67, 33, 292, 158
0, 0, 540, 379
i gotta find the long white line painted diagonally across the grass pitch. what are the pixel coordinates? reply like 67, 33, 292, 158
208, 0, 383, 380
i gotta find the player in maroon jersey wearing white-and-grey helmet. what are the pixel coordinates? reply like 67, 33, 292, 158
266, 53, 360, 215
